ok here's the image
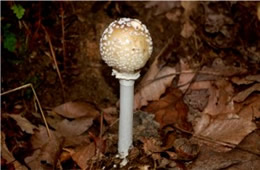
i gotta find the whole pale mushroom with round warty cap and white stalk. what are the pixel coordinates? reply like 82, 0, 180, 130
100, 18, 153, 158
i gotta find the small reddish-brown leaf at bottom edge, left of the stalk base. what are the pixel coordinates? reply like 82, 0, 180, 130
72, 142, 96, 169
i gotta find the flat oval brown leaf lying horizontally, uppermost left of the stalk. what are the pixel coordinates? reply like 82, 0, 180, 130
53, 102, 99, 118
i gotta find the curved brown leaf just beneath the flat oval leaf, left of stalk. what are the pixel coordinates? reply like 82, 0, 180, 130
56, 117, 94, 137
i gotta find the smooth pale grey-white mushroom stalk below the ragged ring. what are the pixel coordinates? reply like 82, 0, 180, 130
118, 79, 134, 158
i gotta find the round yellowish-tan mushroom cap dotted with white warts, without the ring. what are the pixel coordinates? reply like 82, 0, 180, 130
100, 18, 153, 77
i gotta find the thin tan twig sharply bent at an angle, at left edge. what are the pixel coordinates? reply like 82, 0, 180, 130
0, 83, 51, 137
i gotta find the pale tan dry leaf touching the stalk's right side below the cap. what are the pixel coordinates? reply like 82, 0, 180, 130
134, 64, 176, 109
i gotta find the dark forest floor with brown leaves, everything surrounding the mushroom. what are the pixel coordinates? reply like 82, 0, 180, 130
1, 1, 260, 170
